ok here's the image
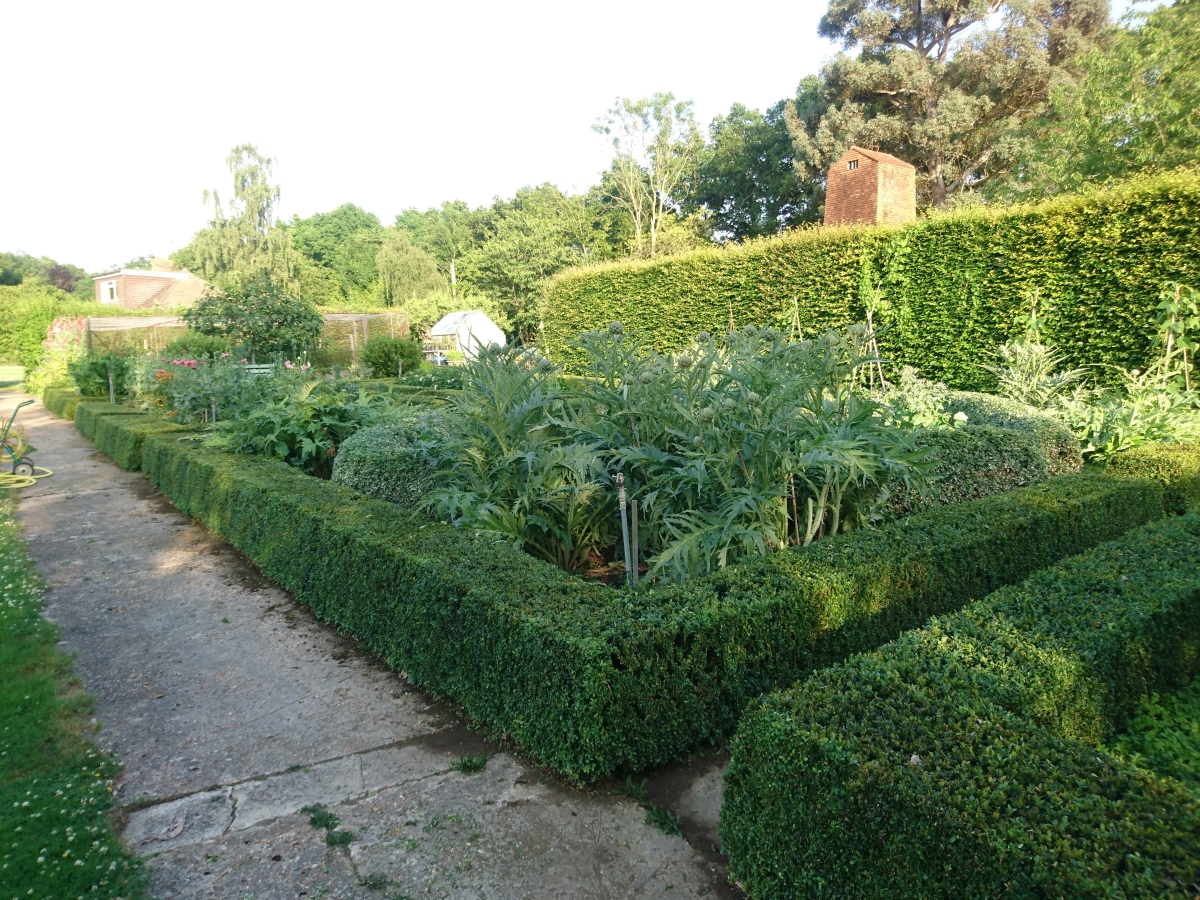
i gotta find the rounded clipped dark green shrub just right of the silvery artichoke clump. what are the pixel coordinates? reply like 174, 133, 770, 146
884, 425, 1050, 515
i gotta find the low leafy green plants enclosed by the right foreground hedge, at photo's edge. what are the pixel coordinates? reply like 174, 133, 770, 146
1112, 678, 1200, 794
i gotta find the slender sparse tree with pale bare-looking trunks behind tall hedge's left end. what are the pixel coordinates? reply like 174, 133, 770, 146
593, 94, 703, 257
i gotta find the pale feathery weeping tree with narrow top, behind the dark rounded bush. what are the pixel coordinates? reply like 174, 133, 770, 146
175, 144, 302, 289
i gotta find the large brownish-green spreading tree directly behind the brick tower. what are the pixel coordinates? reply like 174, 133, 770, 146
787, 0, 1108, 206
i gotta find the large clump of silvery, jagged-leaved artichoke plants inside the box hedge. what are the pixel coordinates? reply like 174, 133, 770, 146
436, 323, 924, 581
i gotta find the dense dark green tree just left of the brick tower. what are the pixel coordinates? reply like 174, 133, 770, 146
680, 95, 818, 240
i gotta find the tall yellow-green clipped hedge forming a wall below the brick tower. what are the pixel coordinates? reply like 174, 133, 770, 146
542, 172, 1200, 390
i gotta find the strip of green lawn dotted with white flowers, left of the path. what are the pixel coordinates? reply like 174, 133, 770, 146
0, 497, 143, 900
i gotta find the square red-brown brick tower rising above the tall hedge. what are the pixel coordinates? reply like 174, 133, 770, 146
824, 146, 917, 224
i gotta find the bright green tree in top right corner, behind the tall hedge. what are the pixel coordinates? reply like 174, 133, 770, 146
997, 0, 1200, 196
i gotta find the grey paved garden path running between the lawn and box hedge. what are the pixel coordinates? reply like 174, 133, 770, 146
0, 392, 737, 900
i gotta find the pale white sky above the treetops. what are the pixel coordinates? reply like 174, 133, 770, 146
0, 0, 1137, 271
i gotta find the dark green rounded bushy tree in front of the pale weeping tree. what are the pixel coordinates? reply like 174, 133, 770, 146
184, 276, 325, 361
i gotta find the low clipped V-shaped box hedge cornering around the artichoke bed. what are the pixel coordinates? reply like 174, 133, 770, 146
126, 412, 1163, 782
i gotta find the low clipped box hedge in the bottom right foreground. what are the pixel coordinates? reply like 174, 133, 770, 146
721, 515, 1200, 900
